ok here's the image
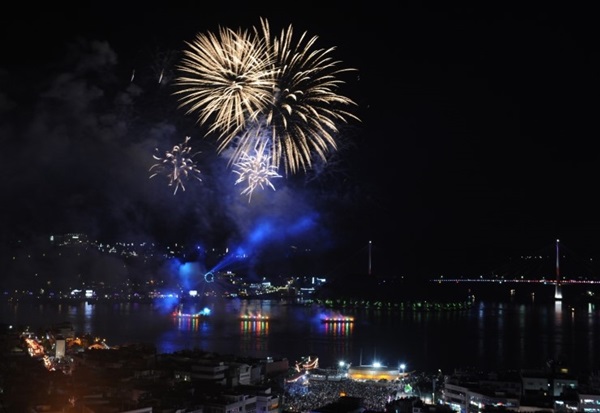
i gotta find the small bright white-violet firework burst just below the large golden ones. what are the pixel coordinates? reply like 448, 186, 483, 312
233, 141, 281, 202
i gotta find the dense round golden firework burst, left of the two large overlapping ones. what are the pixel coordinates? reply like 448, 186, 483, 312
175, 28, 273, 142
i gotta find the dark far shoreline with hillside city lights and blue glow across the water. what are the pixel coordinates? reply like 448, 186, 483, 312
0, 233, 600, 297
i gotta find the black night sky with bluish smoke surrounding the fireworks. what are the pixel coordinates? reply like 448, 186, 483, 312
0, 2, 600, 277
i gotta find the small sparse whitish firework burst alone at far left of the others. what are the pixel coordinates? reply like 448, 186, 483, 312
150, 136, 202, 195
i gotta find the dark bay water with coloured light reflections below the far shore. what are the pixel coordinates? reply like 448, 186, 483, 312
0, 299, 600, 373
